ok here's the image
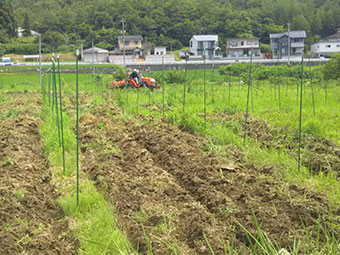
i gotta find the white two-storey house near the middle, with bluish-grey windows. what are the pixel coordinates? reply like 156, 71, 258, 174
189, 35, 219, 57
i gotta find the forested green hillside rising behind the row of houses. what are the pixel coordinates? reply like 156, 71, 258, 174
0, 0, 340, 51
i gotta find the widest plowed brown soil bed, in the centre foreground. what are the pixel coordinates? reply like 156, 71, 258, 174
80, 102, 336, 254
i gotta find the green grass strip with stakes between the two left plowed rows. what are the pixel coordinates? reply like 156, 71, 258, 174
40, 76, 134, 255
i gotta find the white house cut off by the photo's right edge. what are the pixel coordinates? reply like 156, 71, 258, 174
311, 28, 340, 57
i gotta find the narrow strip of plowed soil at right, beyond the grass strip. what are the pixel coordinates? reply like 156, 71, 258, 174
208, 113, 340, 175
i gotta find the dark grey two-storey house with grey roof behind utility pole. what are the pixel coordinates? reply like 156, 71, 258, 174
269, 30, 307, 58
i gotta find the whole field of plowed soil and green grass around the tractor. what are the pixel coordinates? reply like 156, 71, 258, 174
0, 63, 340, 255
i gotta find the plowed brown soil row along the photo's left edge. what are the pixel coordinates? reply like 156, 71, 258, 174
0, 93, 77, 255
